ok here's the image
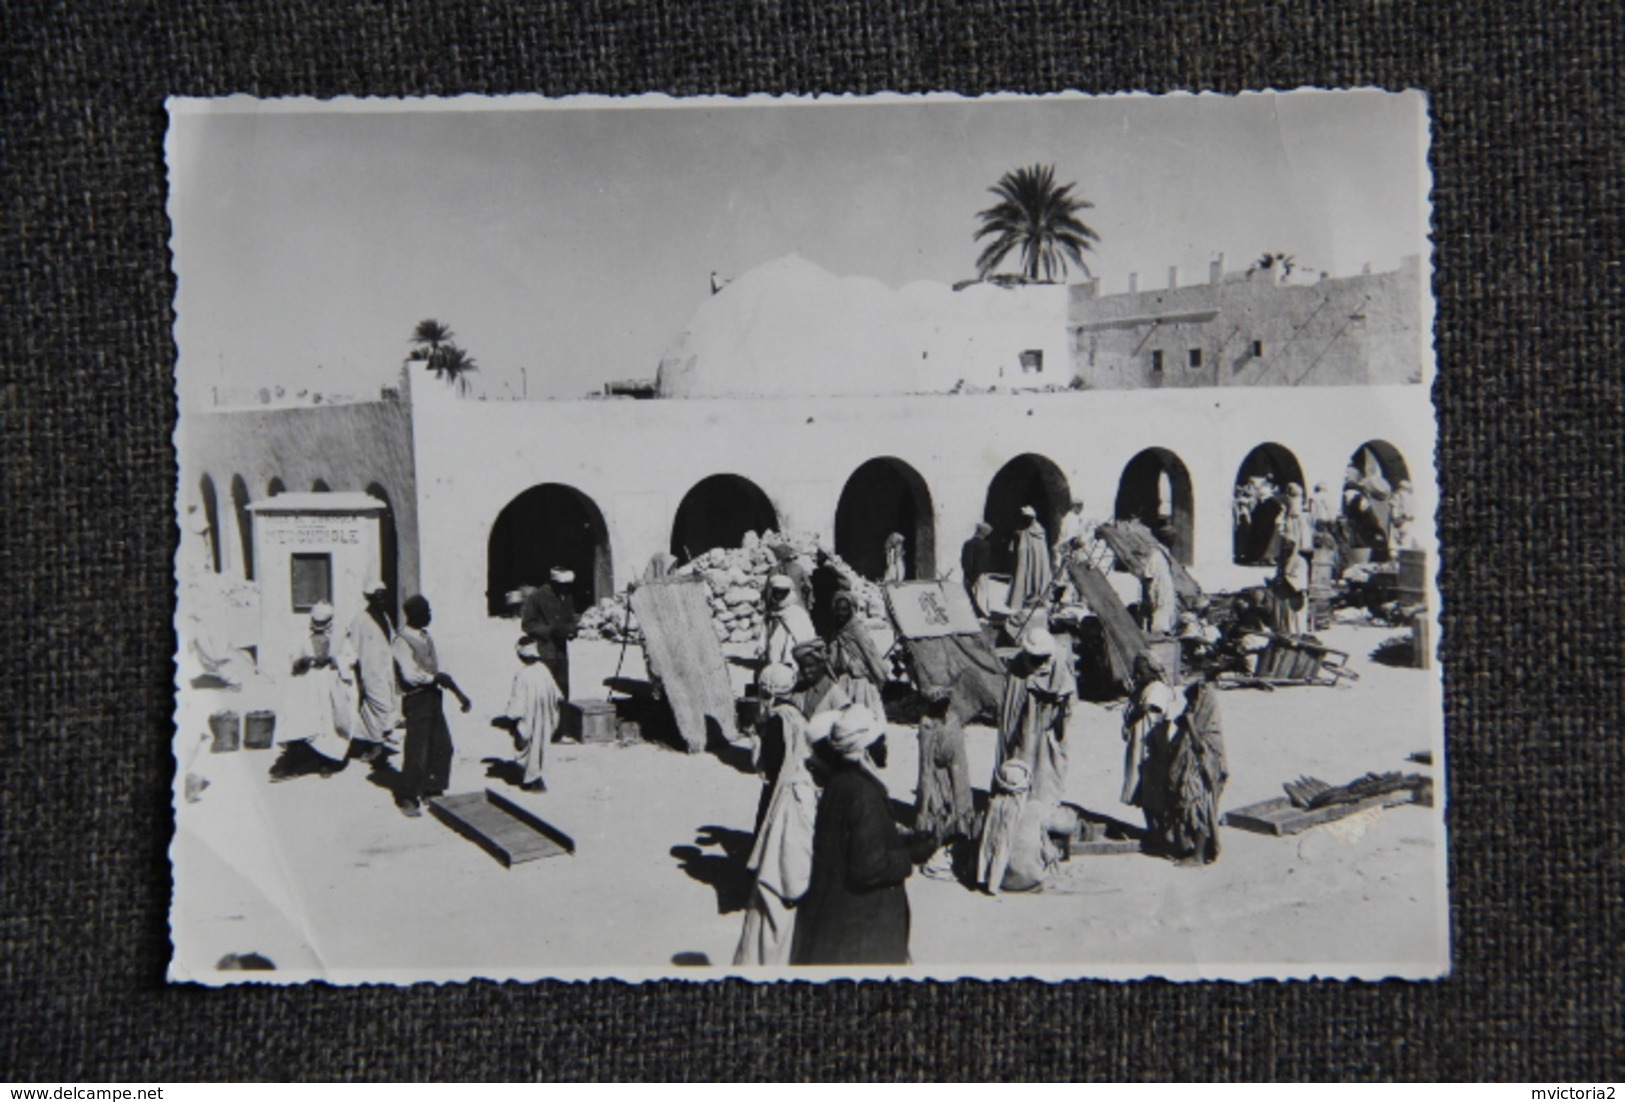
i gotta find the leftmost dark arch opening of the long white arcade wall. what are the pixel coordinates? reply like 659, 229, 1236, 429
484, 483, 614, 616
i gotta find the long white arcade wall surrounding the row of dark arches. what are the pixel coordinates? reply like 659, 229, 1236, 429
414, 385, 1435, 685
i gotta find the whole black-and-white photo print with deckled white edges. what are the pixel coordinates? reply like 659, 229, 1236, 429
166, 89, 1450, 985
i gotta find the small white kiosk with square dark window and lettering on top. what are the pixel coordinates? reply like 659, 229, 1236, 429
249, 492, 393, 679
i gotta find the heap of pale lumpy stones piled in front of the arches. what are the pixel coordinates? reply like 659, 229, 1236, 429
577, 531, 886, 644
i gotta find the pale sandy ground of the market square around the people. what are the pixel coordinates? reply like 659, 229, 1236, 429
172, 626, 1448, 982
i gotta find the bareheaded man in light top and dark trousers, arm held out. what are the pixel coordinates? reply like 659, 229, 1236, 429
393, 595, 473, 819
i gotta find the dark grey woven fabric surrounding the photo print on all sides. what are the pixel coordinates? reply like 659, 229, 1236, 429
0, 0, 1625, 1082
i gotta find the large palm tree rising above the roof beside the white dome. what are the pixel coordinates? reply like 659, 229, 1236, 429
975, 164, 1100, 283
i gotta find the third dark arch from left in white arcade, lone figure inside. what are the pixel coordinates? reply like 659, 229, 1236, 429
835, 455, 936, 582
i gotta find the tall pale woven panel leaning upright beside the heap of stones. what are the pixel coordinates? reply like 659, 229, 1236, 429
632, 577, 735, 754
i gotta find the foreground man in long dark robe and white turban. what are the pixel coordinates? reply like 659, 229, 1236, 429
790, 705, 913, 964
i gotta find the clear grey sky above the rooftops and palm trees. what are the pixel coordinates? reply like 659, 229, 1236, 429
167, 91, 1428, 405
